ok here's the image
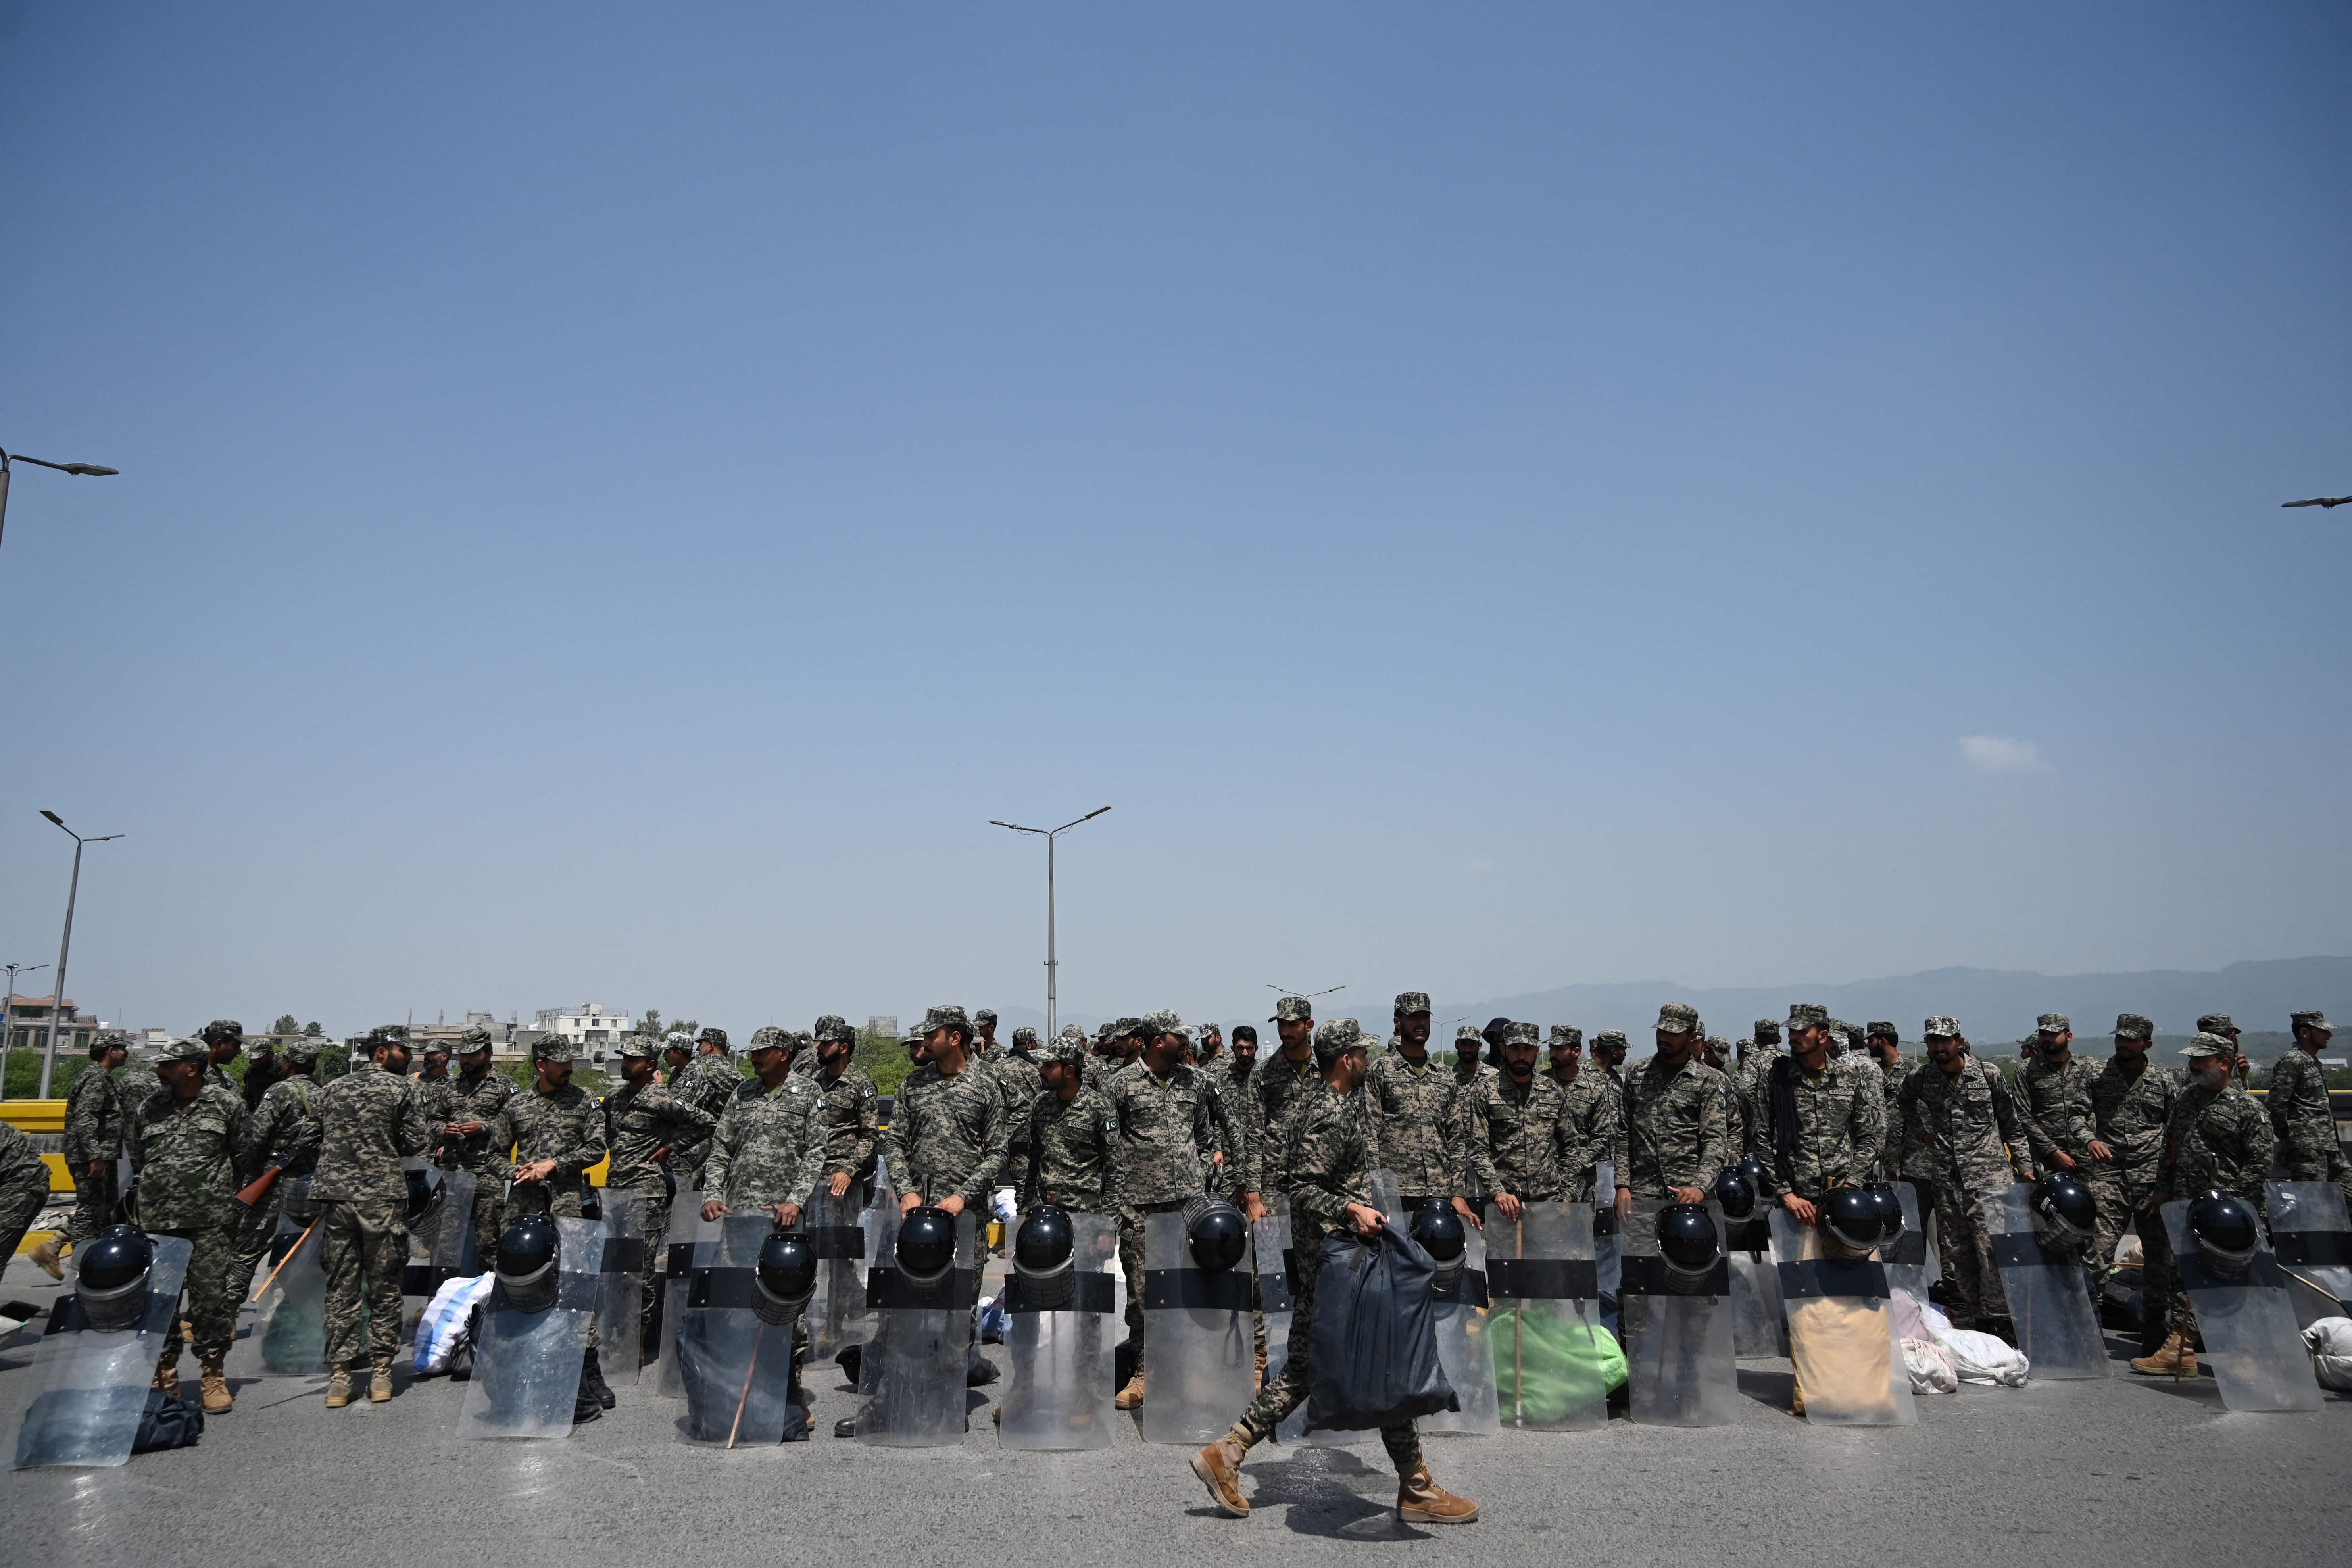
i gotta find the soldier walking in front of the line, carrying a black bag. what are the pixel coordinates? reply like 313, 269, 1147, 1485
1192, 1018, 1468, 1523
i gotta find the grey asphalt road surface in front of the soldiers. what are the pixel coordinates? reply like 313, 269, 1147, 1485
0, 1260, 2352, 1568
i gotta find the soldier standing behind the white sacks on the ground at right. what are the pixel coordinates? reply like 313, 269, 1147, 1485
1903, 1018, 2035, 1337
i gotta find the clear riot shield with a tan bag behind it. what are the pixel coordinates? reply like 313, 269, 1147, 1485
1771, 1208, 1919, 1427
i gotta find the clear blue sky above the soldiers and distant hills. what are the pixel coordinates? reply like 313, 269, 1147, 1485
0, 5, 2352, 1030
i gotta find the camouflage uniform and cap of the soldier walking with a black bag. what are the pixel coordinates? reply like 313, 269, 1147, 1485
1225, 1018, 1411, 1476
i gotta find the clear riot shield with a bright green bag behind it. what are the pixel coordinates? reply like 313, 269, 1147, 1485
1486, 1204, 1611, 1432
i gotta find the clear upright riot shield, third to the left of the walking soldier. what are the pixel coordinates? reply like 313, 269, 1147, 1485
859, 1208, 978, 1448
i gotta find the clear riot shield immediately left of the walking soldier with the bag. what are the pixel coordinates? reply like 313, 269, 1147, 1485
1136, 1211, 1261, 1446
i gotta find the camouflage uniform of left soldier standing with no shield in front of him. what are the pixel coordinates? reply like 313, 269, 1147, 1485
313, 1063, 433, 1366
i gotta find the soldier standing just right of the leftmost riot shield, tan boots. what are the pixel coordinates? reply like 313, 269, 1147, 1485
129, 1039, 247, 1415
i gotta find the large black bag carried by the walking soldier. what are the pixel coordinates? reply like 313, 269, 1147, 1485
1308, 1225, 1460, 1432
